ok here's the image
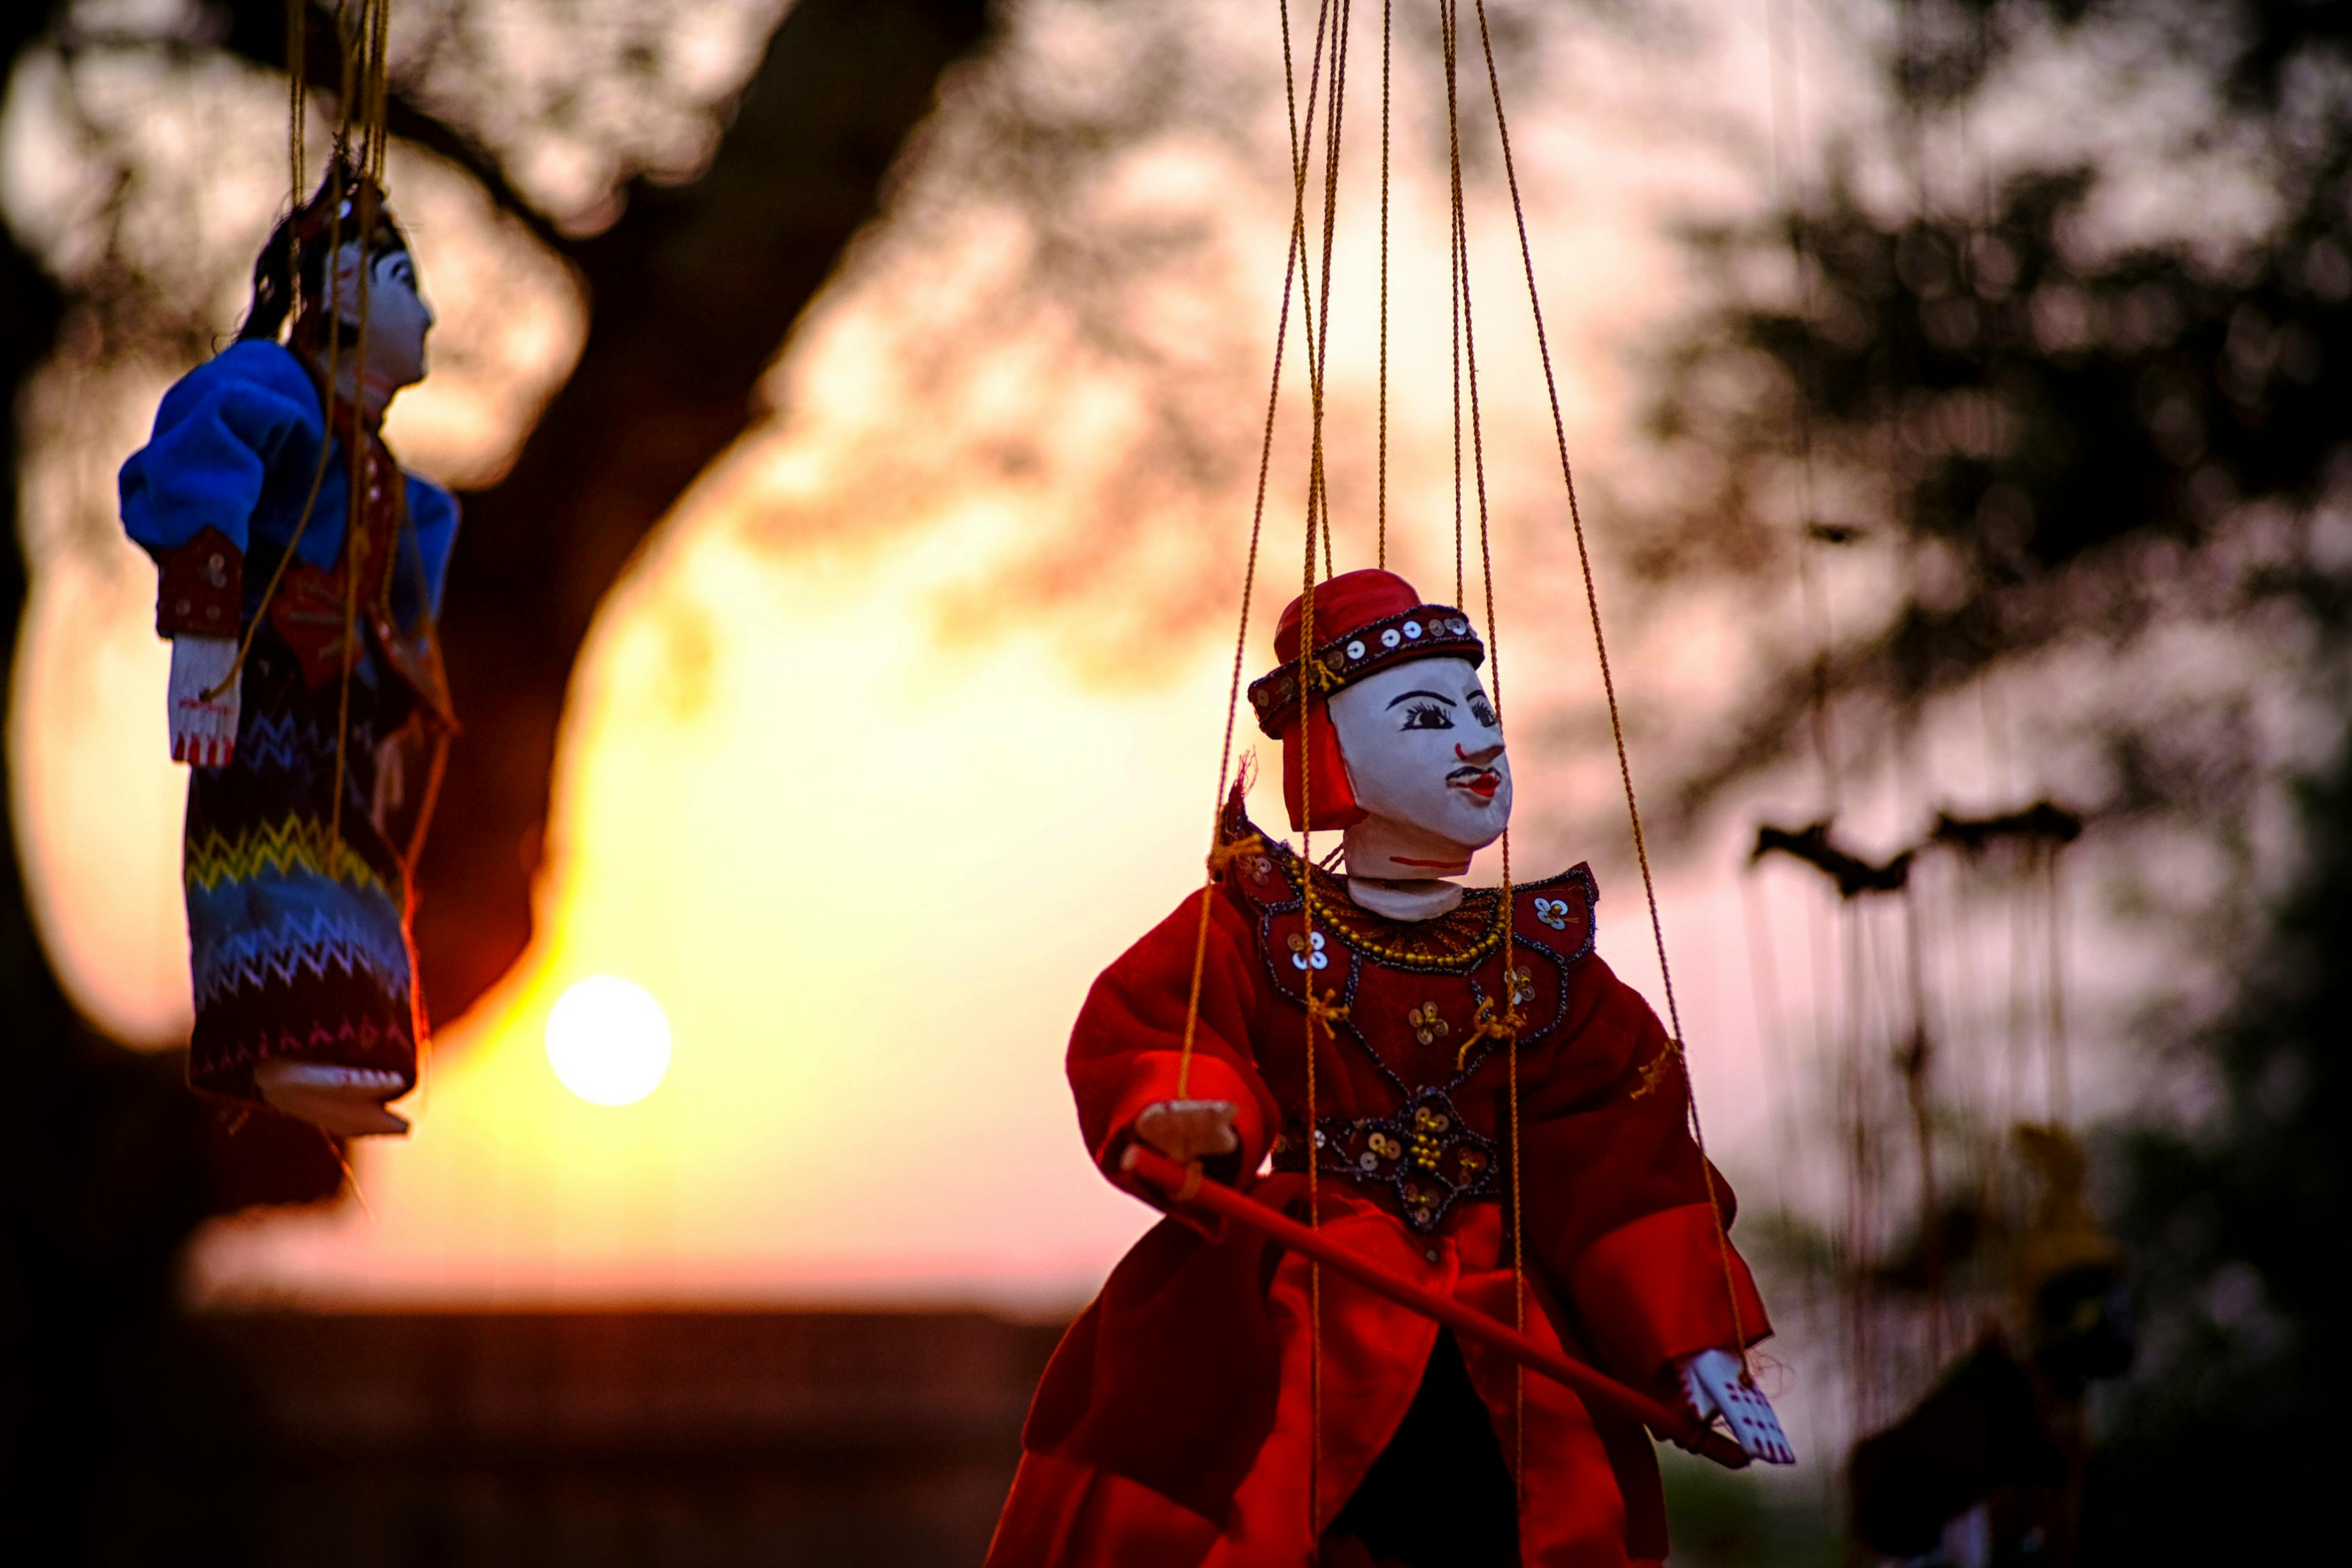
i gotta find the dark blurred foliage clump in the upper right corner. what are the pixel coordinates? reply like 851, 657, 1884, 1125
1642, 0, 2352, 827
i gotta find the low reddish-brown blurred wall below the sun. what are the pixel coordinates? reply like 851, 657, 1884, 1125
205, 1312, 1061, 1568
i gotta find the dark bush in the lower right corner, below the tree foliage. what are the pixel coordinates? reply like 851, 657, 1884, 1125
2091, 752, 2352, 1563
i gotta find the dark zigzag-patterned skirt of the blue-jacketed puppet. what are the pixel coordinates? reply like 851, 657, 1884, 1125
183, 625, 424, 1100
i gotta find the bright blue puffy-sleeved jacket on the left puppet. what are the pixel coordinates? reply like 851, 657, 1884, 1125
120, 341, 456, 625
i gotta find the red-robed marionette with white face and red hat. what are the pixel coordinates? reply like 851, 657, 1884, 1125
988, 571, 1792, 1568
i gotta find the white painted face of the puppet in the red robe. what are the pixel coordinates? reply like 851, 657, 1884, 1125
1331, 659, 1510, 877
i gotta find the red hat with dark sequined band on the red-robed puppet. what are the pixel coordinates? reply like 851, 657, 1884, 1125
1249, 569, 1486, 832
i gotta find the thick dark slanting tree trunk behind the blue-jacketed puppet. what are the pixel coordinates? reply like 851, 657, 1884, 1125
211, 0, 988, 1015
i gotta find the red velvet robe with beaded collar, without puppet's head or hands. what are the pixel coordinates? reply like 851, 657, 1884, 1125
988, 813, 1769, 1568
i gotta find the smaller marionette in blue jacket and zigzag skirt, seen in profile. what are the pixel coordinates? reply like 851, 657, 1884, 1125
123, 160, 456, 1135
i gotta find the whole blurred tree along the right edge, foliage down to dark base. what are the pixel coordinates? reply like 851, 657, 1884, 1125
1642, 0, 2352, 1563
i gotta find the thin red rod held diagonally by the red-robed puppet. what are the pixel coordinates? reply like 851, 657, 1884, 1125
1120, 1142, 1748, 1469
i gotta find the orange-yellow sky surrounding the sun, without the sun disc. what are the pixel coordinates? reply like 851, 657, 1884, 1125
10, 6, 2013, 1309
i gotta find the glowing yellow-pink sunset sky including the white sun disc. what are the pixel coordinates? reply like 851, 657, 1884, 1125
10, 6, 1815, 1312
